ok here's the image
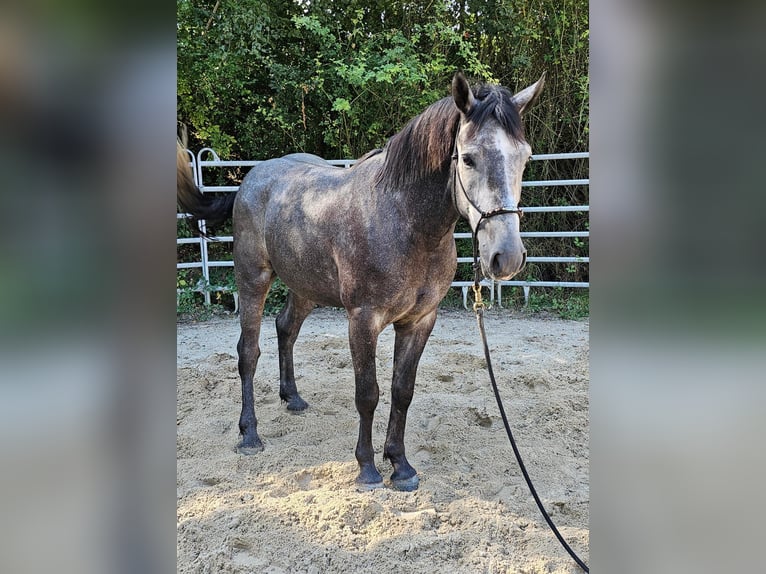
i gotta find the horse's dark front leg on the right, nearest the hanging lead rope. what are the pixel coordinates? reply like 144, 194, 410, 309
383, 310, 436, 491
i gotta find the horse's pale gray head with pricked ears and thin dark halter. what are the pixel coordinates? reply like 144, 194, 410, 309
452, 73, 544, 280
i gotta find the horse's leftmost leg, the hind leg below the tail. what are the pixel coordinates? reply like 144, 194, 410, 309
237, 269, 272, 454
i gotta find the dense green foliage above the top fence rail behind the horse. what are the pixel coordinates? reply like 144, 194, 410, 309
176, 0, 588, 159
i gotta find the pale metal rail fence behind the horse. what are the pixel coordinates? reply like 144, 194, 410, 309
176, 148, 590, 310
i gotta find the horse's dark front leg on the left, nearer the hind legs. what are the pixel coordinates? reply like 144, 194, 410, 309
348, 309, 383, 490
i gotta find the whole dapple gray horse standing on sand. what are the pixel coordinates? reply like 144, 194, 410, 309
178, 73, 544, 490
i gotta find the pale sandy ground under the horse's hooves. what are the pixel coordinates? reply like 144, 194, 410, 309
177, 308, 589, 574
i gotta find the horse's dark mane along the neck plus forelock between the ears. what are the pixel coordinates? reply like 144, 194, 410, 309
377, 84, 524, 189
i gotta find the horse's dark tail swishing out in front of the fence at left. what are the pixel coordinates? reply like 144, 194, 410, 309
176, 142, 237, 237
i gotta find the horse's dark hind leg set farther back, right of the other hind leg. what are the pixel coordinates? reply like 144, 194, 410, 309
277, 291, 315, 411
